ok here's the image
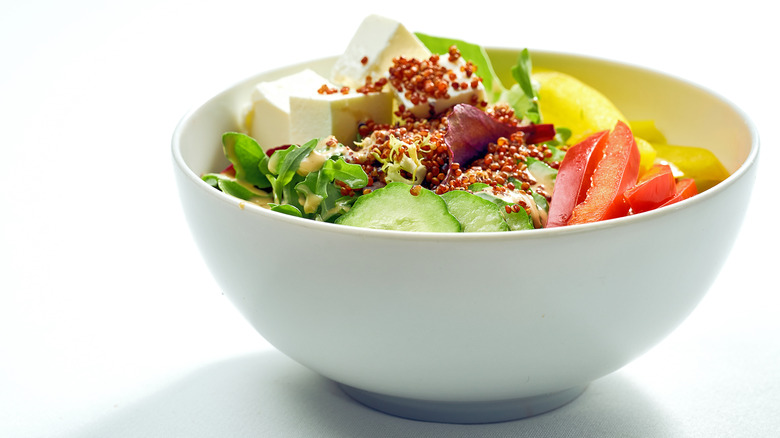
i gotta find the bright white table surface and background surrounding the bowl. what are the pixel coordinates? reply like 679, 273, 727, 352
0, 0, 780, 437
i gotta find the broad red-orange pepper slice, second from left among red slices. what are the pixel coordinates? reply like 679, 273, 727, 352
568, 121, 639, 225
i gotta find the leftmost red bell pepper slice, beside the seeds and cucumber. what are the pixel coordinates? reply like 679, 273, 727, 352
546, 131, 609, 228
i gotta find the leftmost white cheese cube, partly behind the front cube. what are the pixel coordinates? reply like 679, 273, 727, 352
246, 69, 328, 150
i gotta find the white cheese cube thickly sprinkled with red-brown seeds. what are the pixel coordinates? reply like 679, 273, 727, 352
391, 54, 487, 118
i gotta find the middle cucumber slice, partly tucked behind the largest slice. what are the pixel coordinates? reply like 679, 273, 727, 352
441, 190, 509, 233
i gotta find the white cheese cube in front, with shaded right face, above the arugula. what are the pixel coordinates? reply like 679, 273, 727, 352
290, 91, 393, 146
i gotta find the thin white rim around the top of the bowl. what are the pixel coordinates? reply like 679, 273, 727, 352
171, 46, 760, 242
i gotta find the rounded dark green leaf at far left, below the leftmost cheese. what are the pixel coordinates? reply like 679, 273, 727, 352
222, 132, 271, 189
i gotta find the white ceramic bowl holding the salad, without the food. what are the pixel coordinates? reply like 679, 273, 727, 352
173, 49, 758, 423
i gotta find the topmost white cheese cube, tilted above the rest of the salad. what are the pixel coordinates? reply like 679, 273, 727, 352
330, 15, 431, 89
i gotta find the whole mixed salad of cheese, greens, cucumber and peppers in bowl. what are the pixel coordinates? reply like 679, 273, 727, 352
203, 16, 729, 232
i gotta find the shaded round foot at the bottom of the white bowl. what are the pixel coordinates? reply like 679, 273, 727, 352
338, 383, 587, 424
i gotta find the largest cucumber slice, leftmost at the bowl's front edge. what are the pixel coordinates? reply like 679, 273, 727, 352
336, 182, 461, 233
